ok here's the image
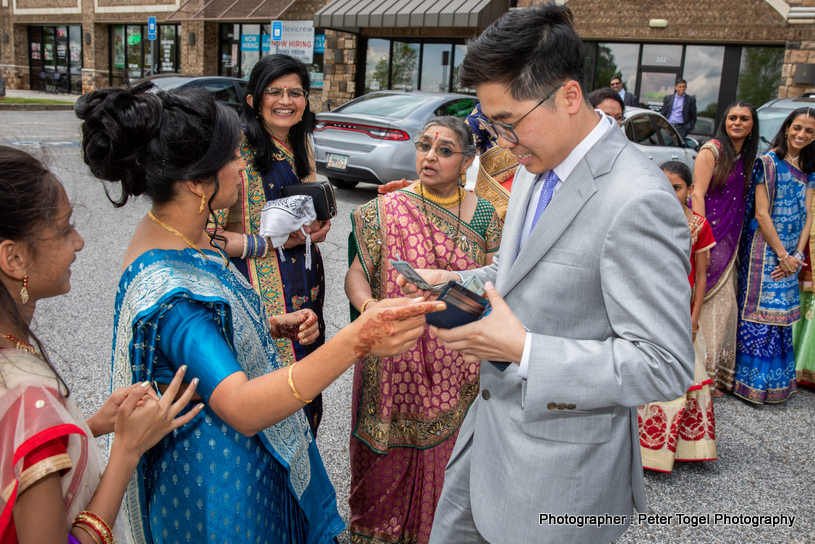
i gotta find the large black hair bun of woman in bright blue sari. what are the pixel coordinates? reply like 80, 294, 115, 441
74, 85, 162, 204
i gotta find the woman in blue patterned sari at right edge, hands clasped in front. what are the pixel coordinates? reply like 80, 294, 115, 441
733, 108, 815, 404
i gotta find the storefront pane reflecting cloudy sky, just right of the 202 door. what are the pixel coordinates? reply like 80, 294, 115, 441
683, 45, 724, 119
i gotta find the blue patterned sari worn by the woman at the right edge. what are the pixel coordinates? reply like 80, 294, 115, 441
733, 151, 815, 404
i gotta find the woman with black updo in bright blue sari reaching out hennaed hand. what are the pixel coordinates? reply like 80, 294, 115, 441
76, 84, 443, 544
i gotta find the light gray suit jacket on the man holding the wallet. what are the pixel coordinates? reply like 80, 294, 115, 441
452, 124, 694, 544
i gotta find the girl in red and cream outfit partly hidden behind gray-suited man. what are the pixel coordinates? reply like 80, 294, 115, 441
639, 161, 717, 472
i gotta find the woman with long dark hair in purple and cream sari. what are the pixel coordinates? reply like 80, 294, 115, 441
691, 102, 758, 396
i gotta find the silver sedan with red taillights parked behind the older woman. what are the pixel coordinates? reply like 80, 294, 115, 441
314, 91, 478, 189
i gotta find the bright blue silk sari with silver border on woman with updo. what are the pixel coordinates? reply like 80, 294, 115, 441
112, 249, 343, 544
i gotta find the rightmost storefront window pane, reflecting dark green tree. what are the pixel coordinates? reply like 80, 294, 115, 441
736, 47, 784, 108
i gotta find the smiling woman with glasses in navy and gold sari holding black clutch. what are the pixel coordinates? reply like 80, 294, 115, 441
212, 55, 331, 435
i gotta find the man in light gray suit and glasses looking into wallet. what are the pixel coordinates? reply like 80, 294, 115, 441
399, 3, 694, 544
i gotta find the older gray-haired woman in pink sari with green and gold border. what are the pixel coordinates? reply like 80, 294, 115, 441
345, 117, 502, 544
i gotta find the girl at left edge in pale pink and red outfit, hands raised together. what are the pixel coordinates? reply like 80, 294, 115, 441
0, 146, 203, 544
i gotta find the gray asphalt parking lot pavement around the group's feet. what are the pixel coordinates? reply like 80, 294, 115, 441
7, 112, 815, 544
